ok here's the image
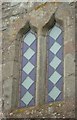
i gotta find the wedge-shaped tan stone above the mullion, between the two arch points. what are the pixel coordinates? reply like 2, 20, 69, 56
29, 3, 59, 28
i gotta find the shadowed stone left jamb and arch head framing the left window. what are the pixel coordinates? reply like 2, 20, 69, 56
11, 21, 37, 109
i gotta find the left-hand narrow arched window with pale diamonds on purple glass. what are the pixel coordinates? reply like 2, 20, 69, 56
20, 30, 36, 107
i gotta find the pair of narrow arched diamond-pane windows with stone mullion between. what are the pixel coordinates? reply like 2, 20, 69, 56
19, 24, 63, 107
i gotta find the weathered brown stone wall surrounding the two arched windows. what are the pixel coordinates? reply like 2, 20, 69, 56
2, 2, 75, 118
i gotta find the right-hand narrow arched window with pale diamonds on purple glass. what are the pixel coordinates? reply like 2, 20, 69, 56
47, 24, 63, 102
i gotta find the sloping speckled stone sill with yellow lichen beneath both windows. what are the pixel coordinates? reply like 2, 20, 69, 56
8, 100, 75, 118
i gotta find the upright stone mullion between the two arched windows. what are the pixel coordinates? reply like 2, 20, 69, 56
36, 28, 46, 105
